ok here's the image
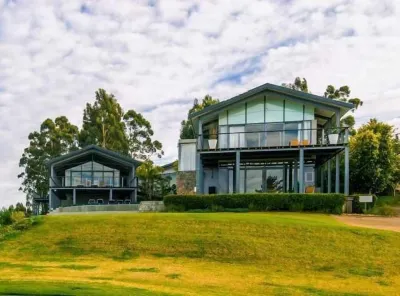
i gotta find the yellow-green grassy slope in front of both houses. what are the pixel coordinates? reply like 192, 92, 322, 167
0, 213, 400, 295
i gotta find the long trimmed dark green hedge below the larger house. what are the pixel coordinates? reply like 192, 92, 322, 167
164, 193, 345, 214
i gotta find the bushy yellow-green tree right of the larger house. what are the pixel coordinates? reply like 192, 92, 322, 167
350, 119, 397, 193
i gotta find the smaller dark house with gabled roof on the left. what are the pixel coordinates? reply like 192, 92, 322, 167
47, 145, 140, 210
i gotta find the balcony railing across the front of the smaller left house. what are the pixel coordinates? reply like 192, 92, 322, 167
52, 176, 138, 188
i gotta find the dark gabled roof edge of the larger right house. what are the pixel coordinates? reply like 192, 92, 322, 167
189, 83, 354, 119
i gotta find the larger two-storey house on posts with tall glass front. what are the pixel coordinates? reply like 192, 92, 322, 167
177, 84, 353, 194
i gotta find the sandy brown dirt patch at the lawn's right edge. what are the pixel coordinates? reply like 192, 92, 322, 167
335, 215, 400, 232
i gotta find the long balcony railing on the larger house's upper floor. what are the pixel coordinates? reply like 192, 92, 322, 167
198, 127, 348, 150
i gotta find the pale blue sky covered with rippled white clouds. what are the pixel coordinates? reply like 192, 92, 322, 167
0, 0, 400, 206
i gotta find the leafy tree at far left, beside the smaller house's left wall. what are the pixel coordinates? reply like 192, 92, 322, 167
18, 116, 78, 205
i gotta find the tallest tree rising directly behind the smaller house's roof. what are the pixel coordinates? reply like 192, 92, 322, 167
79, 89, 129, 154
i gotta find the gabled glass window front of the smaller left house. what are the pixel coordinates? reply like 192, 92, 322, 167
64, 161, 121, 187
